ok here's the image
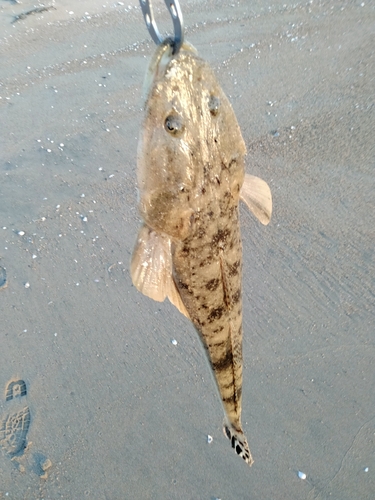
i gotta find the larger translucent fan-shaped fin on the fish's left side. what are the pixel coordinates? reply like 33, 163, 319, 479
130, 225, 189, 318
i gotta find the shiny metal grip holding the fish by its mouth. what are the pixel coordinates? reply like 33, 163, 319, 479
139, 0, 184, 54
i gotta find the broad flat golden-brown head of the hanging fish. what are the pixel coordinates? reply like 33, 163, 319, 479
137, 43, 246, 239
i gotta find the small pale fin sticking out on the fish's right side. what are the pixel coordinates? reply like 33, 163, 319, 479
240, 174, 272, 226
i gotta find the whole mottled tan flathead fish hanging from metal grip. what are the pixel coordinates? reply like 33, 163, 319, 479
130, 41, 272, 466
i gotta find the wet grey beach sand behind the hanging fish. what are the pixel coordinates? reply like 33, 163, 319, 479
0, 0, 375, 500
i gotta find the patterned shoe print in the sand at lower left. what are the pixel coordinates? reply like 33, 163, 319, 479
0, 380, 30, 457
